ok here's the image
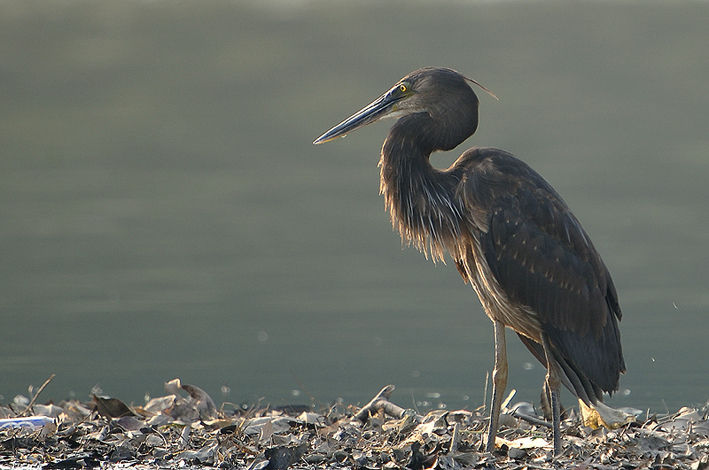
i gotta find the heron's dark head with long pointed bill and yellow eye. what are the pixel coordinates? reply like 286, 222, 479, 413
313, 67, 497, 144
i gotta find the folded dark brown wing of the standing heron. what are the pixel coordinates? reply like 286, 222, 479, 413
457, 149, 625, 391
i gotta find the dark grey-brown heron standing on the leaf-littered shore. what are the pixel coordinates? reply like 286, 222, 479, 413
313, 67, 625, 455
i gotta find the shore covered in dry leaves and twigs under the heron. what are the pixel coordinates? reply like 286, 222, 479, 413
0, 379, 709, 470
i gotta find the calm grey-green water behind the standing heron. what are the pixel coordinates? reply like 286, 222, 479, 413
0, 1, 709, 411
